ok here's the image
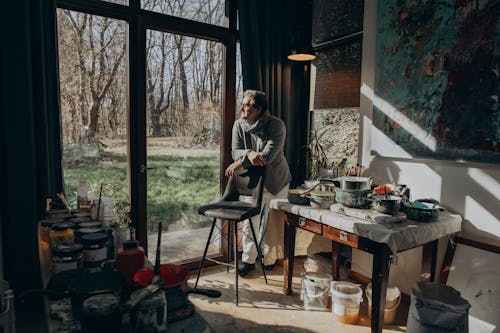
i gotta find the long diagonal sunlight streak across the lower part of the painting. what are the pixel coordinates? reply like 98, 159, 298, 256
361, 83, 436, 151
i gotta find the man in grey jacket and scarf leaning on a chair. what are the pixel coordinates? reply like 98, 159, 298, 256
225, 90, 292, 276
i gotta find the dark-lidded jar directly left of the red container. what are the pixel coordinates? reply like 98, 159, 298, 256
81, 232, 108, 271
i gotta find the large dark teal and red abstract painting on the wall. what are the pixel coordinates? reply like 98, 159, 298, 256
372, 0, 500, 163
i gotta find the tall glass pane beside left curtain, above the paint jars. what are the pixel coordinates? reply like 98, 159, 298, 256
57, 9, 128, 223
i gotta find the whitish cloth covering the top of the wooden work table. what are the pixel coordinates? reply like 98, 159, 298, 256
270, 199, 462, 253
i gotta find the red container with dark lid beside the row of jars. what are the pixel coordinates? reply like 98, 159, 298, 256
116, 240, 146, 283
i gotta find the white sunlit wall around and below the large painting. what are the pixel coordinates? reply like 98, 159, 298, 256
352, 0, 500, 294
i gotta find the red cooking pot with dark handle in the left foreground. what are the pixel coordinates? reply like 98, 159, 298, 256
134, 264, 221, 311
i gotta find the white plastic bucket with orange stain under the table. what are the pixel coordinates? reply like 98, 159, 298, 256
331, 281, 363, 324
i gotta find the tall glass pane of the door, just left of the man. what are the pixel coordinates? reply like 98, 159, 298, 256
146, 30, 223, 262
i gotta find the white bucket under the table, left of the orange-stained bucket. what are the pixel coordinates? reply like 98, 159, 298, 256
301, 273, 332, 311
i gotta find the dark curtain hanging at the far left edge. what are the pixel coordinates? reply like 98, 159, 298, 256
0, 0, 62, 294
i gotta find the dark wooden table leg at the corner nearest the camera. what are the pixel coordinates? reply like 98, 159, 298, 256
371, 244, 391, 333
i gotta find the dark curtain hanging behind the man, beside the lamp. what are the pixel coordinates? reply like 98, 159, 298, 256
238, 0, 312, 186
